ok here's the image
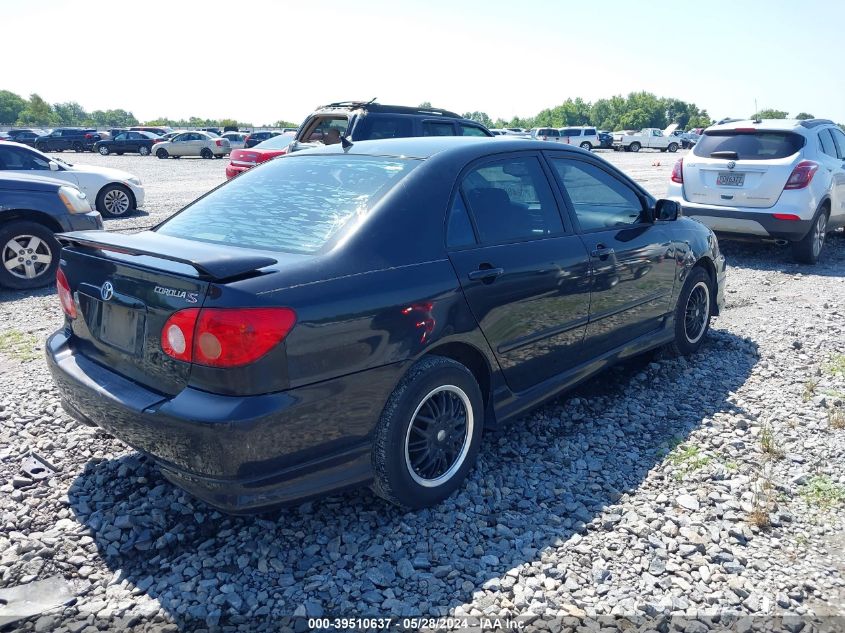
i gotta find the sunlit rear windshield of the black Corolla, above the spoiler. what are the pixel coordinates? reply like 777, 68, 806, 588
157, 154, 420, 253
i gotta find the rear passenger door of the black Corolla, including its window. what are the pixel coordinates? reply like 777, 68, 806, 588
447, 152, 589, 392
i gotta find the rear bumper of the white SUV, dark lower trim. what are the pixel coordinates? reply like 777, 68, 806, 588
678, 200, 812, 242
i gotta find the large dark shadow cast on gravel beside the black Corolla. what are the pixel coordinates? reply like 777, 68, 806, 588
68, 330, 758, 630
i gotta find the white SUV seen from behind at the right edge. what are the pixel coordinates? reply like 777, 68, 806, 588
668, 119, 845, 264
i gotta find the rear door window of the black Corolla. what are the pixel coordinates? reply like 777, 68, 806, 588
461, 156, 563, 244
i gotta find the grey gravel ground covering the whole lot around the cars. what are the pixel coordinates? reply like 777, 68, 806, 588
0, 152, 845, 633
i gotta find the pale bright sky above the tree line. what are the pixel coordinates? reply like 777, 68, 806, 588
0, 0, 845, 125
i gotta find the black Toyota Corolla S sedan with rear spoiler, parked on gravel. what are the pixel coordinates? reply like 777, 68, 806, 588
47, 137, 725, 512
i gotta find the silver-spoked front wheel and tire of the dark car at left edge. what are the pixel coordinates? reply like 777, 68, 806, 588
0, 221, 62, 290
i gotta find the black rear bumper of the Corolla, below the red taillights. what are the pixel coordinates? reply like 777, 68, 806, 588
46, 330, 405, 513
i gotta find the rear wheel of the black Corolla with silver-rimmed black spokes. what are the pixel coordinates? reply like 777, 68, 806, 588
372, 356, 484, 509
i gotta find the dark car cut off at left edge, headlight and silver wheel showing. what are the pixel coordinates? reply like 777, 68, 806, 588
0, 174, 103, 290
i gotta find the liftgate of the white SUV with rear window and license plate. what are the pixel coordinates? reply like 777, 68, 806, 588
684, 128, 804, 209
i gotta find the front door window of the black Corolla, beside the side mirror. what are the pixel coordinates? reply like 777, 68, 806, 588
552, 158, 643, 231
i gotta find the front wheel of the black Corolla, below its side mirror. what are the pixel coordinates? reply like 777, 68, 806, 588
668, 266, 714, 356
